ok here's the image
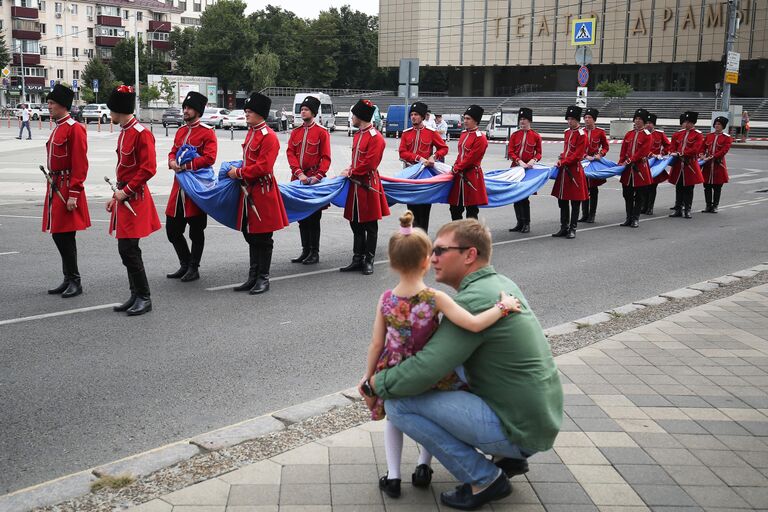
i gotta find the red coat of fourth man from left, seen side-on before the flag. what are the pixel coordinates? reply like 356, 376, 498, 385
232, 122, 288, 233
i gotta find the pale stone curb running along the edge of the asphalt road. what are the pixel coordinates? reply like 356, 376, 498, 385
10, 262, 768, 512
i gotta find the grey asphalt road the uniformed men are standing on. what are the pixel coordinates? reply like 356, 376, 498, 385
0, 122, 768, 493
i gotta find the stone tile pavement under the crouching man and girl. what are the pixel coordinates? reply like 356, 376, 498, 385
131, 285, 768, 512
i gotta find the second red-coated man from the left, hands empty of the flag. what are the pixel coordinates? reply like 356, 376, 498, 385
107, 85, 160, 316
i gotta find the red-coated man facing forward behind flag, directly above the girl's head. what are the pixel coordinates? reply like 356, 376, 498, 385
399, 101, 448, 232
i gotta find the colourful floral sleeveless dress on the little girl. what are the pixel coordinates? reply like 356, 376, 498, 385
371, 288, 464, 420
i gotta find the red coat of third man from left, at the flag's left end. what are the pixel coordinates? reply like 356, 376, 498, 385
165, 120, 219, 218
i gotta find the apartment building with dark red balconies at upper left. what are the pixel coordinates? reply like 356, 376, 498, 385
0, 0, 215, 104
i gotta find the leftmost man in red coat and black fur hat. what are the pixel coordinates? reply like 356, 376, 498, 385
43, 84, 91, 299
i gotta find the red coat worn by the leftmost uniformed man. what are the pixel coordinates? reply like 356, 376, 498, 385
43, 114, 91, 233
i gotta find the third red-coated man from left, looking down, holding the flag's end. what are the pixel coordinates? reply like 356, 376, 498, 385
165, 91, 218, 282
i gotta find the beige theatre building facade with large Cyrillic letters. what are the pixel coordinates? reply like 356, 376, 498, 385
379, 0, 768, 96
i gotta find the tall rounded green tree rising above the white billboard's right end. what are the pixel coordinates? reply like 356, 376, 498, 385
192, 0, 258, 99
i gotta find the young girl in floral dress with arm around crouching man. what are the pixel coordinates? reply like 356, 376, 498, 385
359, 211, 520, 498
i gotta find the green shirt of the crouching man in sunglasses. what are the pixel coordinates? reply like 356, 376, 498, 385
374, 265, 563, 451
